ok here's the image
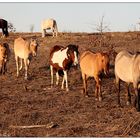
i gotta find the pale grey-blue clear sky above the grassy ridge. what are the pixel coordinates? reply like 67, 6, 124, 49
0, 2, 140, 32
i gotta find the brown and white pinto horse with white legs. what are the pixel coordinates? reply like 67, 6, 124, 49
50, 44, 79, 91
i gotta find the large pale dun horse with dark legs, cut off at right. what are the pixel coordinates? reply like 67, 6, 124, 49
115, 50, 140, 111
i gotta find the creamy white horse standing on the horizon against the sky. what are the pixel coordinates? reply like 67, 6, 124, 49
41, 19, 58, 37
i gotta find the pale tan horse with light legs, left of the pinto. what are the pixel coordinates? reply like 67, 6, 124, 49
14, 37, 38, 79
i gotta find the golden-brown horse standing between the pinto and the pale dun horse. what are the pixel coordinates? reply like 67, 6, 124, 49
80, 51, 109, 101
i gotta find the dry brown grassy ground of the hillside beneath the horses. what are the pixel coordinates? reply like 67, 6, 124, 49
0, 32, 140, 137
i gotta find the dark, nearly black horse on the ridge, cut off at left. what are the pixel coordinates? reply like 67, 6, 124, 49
0, 19, 9, 37
